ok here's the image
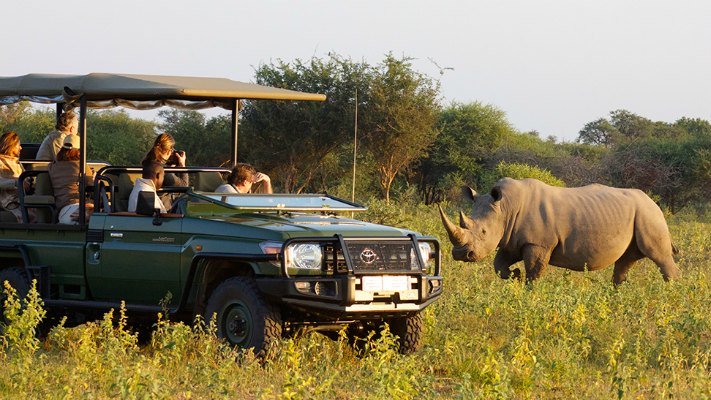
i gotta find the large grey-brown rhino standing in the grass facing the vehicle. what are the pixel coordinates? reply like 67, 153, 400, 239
439, 178, 680, 284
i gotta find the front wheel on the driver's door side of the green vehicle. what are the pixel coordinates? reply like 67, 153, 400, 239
205, 276, 282, 357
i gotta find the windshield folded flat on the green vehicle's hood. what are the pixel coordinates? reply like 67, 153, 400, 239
198, 192, 366, 211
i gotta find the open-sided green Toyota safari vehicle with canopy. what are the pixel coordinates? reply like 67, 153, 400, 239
0, 74, 442, 353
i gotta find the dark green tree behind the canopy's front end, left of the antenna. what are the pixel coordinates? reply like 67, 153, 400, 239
239, 54, 370, 193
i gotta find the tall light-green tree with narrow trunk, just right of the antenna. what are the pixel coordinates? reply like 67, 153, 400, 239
363, 54, 440, 202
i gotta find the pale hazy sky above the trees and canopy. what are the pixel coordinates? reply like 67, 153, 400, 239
5, 0, 711, 140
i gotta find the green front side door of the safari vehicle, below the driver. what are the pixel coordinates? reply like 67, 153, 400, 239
86, 213, 184, 306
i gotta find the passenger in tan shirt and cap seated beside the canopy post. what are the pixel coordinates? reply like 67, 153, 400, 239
49, 135, 93, 225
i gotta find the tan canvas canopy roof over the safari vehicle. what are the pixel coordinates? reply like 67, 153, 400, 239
0, 73, 326, 110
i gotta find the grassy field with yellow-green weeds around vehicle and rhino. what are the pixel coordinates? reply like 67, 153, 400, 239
0, 204, 711, 399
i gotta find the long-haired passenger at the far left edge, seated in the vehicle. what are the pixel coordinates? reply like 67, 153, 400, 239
0, 131, 29, 222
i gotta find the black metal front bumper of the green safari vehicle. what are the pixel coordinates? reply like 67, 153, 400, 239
257, 274, 442, 319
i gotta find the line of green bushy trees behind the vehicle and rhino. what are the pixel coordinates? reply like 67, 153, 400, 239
0, 54, 711, 212
